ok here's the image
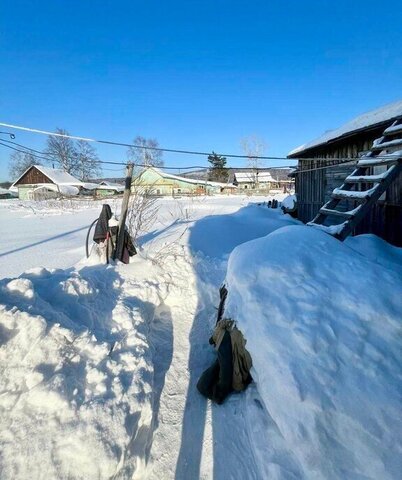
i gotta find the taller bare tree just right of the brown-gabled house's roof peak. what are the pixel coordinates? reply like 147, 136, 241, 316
45, 128, 80, 176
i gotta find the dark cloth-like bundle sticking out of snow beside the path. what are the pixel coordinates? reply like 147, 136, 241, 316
197, 318, 252, 404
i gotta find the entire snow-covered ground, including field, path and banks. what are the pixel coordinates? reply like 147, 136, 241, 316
0, 197, 402, 480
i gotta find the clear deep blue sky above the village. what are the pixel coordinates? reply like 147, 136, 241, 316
0, 0, 402, 181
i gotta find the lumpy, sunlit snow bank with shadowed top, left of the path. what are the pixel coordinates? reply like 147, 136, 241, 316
0, 266, 163, 480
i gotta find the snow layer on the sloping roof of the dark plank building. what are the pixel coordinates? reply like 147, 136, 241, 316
288, 100, 402, 156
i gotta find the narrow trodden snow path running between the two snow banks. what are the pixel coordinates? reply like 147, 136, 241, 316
129, 202, 294, 480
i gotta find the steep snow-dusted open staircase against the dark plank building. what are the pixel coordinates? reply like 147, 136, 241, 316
307, 117, 402, 241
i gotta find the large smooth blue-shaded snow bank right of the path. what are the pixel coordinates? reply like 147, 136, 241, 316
225, 226, 402, 480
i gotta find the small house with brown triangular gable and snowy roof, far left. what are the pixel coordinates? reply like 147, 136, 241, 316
10, 165, 84, 200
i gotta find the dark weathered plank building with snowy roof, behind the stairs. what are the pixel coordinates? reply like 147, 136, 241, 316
288, 101, 402, 246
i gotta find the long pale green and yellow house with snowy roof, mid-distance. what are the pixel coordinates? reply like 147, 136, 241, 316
132, 167, 237, 196
